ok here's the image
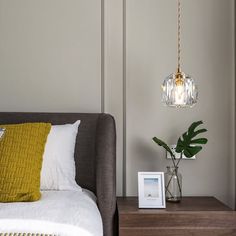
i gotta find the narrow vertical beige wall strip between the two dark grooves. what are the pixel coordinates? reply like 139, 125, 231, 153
104, 0, 125, 196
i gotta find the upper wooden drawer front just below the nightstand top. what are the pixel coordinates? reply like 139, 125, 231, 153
119, 211, 236, 229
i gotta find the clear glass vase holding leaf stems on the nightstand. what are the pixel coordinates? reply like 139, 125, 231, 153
165, 166, 182, 202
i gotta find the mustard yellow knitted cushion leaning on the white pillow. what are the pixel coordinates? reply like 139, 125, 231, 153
0, 123, 51, 202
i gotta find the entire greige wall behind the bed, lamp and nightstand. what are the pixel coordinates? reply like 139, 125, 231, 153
0, 0, 235, 206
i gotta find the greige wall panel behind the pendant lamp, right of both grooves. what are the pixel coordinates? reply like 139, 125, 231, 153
126, 0, 234, 205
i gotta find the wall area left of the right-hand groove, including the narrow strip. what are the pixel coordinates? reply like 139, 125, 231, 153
0, 0, 123, 195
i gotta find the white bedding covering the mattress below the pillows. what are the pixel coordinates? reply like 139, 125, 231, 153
0, 190, 103, 236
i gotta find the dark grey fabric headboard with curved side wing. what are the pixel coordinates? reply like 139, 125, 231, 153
0, 112, 117, 236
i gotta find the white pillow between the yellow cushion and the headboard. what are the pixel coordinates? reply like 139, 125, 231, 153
40, 120, 82, 190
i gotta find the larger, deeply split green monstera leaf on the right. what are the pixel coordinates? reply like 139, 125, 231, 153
175, 121, 208, 158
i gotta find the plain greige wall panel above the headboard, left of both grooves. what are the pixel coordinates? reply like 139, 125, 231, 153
0, 0, 101, 112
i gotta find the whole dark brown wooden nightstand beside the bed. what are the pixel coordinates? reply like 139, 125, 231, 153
117, 197, 236, 236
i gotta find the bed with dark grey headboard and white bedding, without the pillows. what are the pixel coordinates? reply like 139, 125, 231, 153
0, 112, 117, 236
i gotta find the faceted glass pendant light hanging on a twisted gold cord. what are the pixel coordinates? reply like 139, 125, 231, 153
162, 0, 198, 108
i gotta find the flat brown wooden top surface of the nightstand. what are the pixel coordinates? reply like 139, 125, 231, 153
117, 197, 232, 213
